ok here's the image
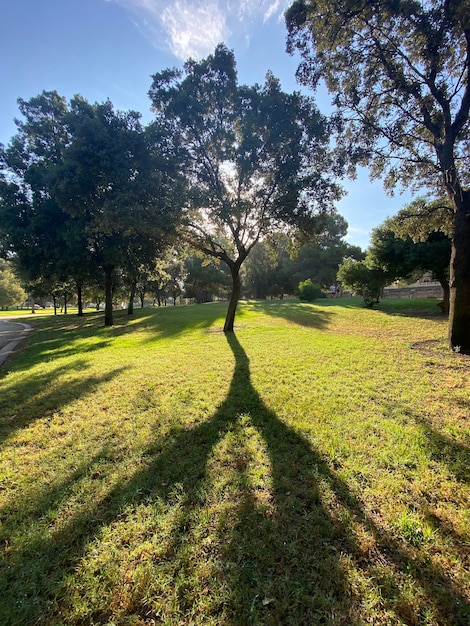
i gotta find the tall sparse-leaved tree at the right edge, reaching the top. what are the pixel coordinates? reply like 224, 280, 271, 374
286, 0, 470, 352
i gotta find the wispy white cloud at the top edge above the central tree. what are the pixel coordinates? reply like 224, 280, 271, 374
108, 0, 289, 60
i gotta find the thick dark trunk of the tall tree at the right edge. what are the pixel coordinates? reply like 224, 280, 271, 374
449, 191, 470, 354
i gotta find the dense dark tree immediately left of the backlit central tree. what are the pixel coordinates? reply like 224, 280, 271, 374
52, 96, 182, 326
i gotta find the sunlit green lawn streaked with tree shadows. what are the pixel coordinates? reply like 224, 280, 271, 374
0, 300, 470, 626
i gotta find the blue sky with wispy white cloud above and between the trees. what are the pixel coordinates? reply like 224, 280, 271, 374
0, 0, 411, 249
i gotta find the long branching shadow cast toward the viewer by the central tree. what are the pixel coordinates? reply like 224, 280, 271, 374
0, 334, 470, 626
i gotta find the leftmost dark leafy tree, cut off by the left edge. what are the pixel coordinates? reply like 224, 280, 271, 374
0, 92, 93, 314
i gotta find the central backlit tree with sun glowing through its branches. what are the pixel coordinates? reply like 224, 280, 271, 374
149, 45, 340, 332
